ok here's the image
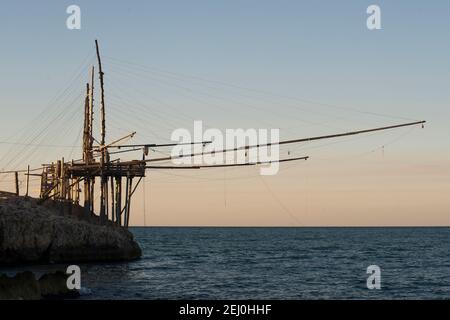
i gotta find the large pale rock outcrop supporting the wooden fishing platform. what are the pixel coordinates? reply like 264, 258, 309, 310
0, 192, 141, 264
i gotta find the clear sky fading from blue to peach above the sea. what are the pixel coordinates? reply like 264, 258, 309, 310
0, 0, 450, 226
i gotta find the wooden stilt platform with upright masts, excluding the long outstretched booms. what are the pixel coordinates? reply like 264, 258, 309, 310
40, 40, 146, 227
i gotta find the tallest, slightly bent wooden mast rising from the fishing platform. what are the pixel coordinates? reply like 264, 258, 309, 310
95, 40, 108, 221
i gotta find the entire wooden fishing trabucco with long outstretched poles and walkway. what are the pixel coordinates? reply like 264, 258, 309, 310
0, 40, 425, 227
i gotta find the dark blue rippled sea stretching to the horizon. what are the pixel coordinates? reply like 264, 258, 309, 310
2, 227, 450, 300
